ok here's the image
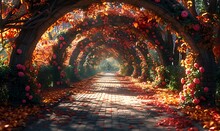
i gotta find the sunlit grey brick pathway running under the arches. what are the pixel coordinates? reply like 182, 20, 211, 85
25, 73, 205, 131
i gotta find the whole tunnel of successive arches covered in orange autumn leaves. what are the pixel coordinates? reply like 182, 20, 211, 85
6, 0, 217, 106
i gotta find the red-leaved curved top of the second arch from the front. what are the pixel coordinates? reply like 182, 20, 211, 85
49, 15, 172, 68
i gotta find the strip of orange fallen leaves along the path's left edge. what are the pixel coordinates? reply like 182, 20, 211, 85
0, 78, 92, 131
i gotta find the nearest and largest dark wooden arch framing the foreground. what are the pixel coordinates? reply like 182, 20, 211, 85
7, 0, 215, 106
